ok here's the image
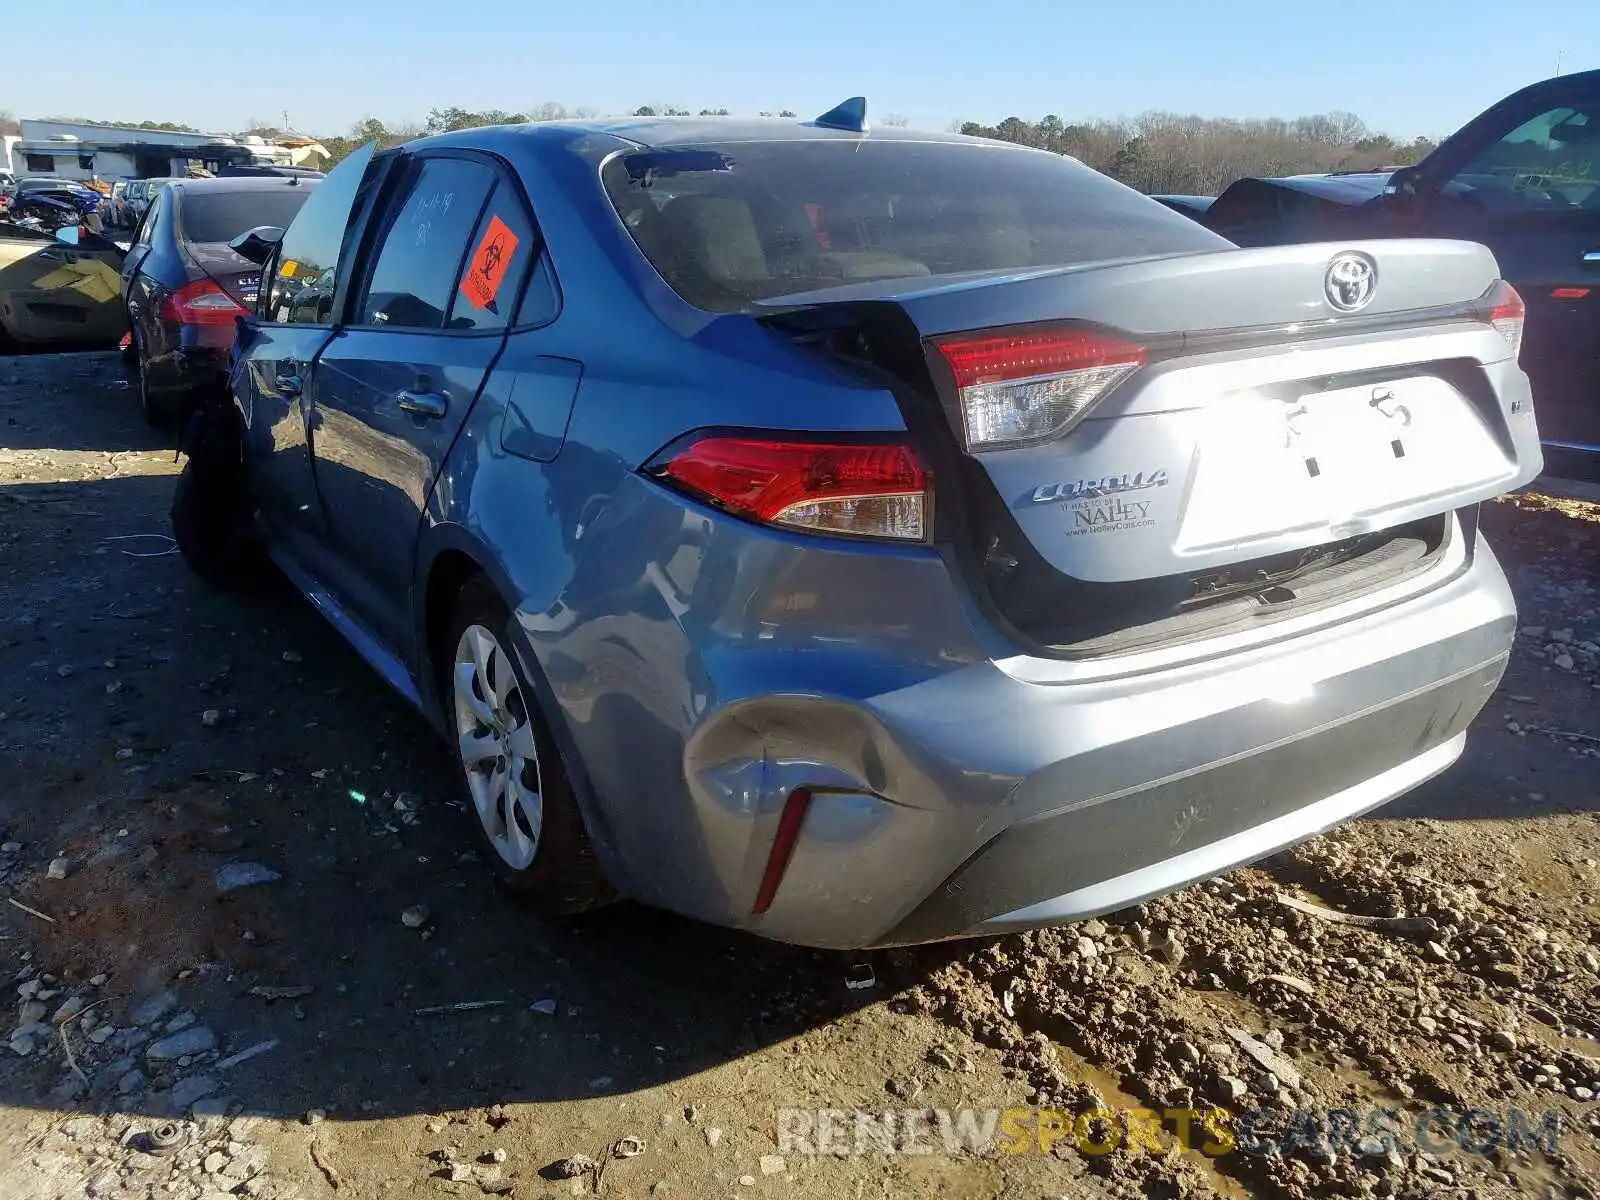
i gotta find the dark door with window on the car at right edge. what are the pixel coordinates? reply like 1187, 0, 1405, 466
1410, 72, 1600, 450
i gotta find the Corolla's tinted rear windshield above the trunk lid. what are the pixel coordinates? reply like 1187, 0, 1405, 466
602, 139, 1227, 312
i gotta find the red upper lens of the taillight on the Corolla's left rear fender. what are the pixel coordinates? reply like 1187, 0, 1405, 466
664, 437, 928, 522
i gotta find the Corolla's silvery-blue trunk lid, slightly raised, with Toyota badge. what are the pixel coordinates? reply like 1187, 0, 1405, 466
755, 240, 1541, 582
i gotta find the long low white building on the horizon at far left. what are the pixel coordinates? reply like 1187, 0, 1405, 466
0, 120, 326, 179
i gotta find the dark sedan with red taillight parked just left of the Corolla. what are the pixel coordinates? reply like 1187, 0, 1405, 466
122, 178, 317, 424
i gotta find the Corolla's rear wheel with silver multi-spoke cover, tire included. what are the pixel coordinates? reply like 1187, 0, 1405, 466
438, 576, 616, 917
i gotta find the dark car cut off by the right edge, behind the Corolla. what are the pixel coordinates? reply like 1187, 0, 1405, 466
1205, 70, 1600, 480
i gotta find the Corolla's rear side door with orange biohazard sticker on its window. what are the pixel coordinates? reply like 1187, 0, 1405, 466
314, 152, 536, 651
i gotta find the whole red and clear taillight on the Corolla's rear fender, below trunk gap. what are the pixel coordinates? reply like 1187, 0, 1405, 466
653, 435, 933, 541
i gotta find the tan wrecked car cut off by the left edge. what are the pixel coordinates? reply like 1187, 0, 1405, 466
0, 224, 126, 347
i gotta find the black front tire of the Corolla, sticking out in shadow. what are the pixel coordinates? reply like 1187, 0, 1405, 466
171, 398, 270, 592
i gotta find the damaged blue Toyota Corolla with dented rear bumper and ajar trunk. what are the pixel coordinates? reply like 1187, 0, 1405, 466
173, 104, 1539, 947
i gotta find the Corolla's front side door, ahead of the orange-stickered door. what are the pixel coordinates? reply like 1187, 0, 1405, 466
230, 144, 376, 573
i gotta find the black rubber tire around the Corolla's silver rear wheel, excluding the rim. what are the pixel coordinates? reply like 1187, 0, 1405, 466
438, 576, 613, 915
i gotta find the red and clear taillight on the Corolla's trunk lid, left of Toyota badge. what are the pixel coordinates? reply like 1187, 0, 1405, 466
934, 330, 1147, 450
